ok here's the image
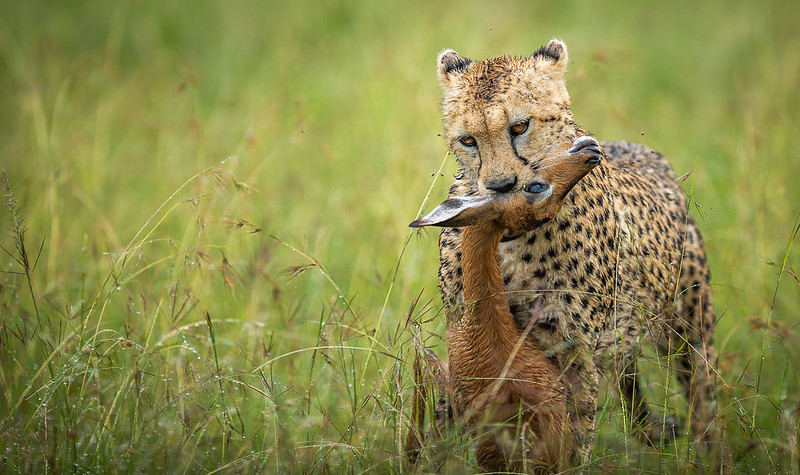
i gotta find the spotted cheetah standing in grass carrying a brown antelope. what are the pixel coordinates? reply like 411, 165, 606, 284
437, 40, 716, 464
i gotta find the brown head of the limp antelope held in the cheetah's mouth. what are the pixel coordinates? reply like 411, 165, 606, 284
410, 136, 603, 232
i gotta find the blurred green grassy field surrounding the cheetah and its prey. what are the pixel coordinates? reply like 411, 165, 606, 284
0, 0, 800, 473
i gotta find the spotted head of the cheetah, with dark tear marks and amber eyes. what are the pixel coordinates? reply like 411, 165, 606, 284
438, 40, 583, 195
